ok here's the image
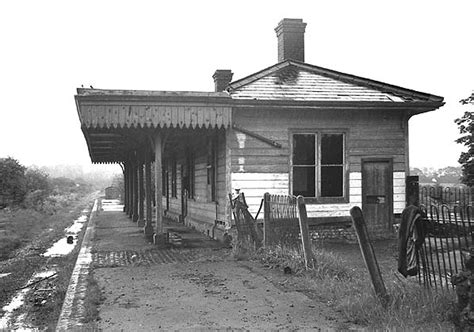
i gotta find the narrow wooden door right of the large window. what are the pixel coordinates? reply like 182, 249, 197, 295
362, 160, 393, 230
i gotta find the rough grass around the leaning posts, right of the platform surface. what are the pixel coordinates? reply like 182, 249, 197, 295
253, 246, 455, 330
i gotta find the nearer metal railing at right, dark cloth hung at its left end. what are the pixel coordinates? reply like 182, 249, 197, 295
399, 205, 474, 289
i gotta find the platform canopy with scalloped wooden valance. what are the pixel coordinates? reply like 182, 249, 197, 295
75, 88, 232, 163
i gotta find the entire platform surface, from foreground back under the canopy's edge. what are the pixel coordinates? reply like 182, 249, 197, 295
92, 202, 345, 331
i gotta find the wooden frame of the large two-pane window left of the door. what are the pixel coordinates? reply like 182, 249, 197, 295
288, 128, 349, 204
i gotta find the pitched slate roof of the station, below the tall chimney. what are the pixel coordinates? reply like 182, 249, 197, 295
227, 60, 443, 106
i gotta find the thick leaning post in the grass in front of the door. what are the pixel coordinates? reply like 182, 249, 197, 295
350, 206, 388, 307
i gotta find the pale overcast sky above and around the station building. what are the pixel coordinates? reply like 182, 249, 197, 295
0, 0, 474, 168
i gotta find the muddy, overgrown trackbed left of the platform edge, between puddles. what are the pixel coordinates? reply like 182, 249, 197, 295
0, 195, 96, 330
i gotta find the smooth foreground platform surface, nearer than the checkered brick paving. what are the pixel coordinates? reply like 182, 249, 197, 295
95, 260, 335, 331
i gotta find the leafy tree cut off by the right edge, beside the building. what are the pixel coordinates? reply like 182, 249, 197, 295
455, 93, 474, 187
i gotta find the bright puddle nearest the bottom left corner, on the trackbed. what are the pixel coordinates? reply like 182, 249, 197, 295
0, 270, 56, 331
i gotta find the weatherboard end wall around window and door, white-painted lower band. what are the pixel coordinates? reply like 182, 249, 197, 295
229, 108, 408, 217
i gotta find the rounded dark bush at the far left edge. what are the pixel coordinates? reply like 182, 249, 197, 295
0, 157, 26, 208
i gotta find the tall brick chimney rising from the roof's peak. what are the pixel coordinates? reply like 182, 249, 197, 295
275, 18, 306, 62
